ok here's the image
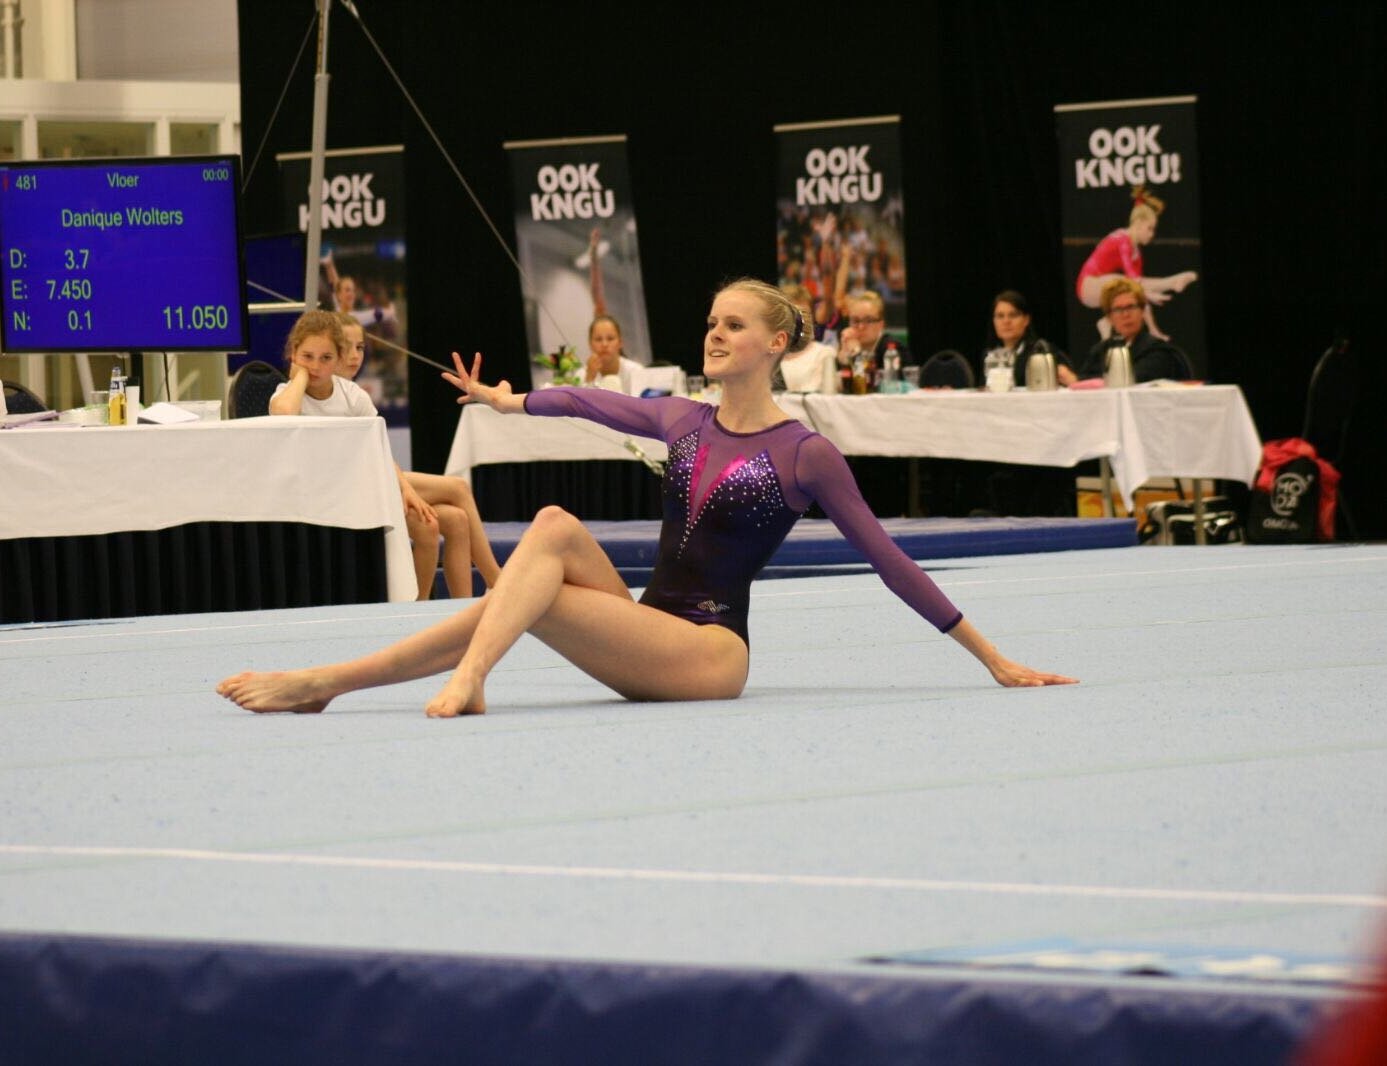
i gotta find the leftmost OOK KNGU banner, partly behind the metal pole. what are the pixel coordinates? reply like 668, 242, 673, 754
275, 146, 409, 427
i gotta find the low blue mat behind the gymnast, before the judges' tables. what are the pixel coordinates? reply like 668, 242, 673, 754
487, 518, 1137, 577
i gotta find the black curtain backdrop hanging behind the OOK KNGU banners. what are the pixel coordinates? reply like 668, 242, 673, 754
240, 0, 1387, 536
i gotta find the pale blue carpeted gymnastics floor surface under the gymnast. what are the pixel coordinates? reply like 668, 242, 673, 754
0, 546, 1387, 1062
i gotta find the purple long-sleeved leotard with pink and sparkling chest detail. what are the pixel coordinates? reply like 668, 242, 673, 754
524, 388, 963, 640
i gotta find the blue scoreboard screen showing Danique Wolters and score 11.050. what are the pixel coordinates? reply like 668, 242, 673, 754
0, 155, 248, 352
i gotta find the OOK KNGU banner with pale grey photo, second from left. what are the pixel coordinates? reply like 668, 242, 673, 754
502, 136, 652, 388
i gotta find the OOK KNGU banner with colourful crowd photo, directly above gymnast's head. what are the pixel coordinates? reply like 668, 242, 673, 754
774, 115, 907, 342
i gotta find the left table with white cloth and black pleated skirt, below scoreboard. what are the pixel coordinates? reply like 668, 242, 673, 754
0, 417, 416, 622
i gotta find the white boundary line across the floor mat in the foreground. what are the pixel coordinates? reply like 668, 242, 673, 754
0, 844, 1387, 909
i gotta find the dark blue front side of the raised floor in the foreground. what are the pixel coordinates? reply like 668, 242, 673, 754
0, 933, 1327, 1066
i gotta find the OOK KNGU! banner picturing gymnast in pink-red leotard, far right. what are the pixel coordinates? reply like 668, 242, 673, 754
1054, 96, 1208, 377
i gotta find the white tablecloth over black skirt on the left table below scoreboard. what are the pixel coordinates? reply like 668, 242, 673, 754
0, 416, 417, 600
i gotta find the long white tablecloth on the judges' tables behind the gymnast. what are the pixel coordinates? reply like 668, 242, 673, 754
447, 385, 1262, 509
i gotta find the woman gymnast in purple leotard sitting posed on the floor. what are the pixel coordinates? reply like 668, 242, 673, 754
216, 279, 1074, 718
